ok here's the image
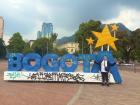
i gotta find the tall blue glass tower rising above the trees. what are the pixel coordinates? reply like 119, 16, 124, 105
42, 22, 53, 37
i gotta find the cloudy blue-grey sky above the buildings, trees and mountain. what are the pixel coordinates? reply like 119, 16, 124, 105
0, 0, 140, 41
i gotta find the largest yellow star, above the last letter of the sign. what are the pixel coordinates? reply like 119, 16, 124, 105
92, 25, 118, 51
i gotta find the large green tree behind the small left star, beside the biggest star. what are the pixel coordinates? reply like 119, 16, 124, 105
75, 20, 101, 53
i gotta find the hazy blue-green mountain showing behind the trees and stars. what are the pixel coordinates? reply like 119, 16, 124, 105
56, 23, 131, 45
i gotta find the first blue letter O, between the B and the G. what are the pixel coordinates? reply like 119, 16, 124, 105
22, 53, 41, 71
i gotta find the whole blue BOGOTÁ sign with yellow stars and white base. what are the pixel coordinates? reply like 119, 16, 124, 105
4, 26, 122, 83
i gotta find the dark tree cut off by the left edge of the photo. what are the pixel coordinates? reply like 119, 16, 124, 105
0, 38, 6, 58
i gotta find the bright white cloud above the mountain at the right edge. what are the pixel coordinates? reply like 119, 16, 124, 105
104, 8, 140, 30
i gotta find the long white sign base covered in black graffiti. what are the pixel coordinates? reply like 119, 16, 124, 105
4, 71, 115, 83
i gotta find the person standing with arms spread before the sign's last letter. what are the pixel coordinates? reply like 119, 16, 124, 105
101, 56, 109, 86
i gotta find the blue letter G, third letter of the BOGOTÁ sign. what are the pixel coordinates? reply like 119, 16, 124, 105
42, 54, 59, 72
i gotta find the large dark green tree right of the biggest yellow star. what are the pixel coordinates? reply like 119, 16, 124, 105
115, 31, 138, 63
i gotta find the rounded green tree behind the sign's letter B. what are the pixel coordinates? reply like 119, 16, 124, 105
7, 32, 25, 53
